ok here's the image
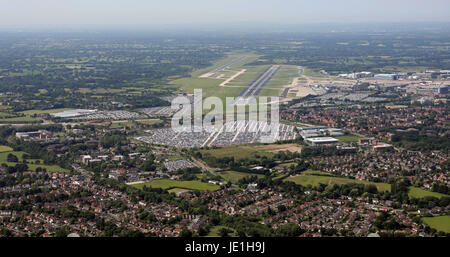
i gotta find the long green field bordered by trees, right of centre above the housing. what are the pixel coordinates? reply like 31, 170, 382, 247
284, 175, 391, 191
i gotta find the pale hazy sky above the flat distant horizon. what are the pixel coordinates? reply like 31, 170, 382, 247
0, 0, 450, 26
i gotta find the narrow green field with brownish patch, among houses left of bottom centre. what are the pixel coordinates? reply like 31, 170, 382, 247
133, 179, 220, 191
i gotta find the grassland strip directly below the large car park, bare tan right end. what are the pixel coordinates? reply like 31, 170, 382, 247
200, 144, 301, 159
